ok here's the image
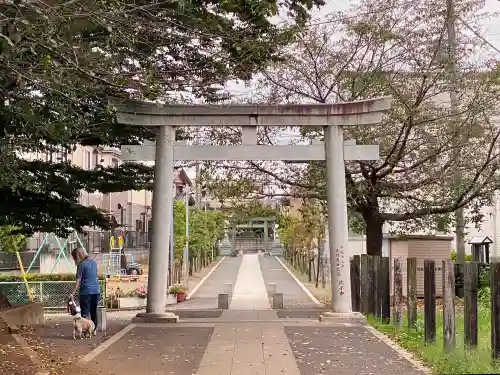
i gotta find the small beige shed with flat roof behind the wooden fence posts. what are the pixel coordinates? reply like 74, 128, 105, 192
389, 235, 453, 297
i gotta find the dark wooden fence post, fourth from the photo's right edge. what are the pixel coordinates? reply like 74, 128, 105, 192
424, 259, 436, 343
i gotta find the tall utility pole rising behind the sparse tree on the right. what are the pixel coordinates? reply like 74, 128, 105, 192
446, 0, 465, 263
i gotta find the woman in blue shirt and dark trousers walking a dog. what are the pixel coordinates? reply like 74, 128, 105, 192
71, 248, 100, 333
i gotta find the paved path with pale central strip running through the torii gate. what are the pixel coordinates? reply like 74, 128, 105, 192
76, 255, 425, 375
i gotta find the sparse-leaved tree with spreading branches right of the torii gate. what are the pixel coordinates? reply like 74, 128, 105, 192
201, 0, 500, 255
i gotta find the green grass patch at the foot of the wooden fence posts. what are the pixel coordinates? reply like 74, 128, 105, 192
367, 305, 500, 374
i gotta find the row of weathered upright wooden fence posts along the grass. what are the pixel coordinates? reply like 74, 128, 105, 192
350, 255, 500, 359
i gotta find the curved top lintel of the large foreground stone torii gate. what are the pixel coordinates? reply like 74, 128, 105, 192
110, 97, 392, 126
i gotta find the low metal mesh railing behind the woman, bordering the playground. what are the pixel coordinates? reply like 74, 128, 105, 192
0, 280, 106, 309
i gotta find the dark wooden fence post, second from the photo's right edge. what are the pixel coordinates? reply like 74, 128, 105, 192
464, 263, 478, 347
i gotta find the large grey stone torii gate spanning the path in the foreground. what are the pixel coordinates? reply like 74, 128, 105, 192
113, 97, 391, 322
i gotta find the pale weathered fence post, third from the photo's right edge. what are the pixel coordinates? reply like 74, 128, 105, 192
443, 259, 456, 352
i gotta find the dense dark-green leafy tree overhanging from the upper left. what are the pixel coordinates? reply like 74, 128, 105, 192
0, 0, 323, 232
